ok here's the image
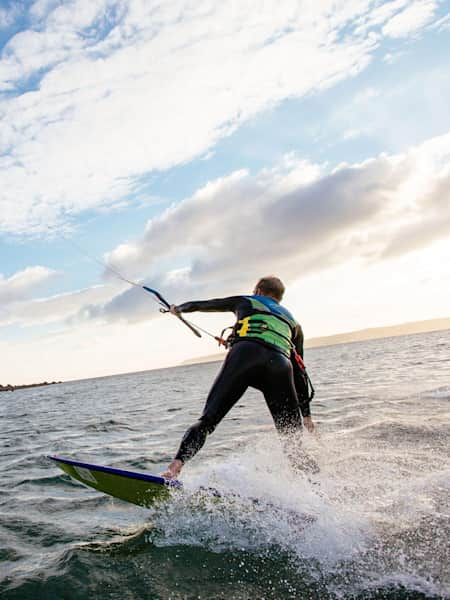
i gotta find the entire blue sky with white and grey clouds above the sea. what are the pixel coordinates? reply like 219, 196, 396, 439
0, 0, 450, 385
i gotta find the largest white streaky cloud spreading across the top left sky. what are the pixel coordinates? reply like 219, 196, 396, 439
0, 0, 440, 234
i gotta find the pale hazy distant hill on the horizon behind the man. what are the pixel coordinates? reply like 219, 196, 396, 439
181, 317, 450, 365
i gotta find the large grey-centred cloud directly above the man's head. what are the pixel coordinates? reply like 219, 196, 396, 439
83, 134, 450, 322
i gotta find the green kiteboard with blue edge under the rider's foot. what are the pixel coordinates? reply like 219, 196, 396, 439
48, 456, 183, 506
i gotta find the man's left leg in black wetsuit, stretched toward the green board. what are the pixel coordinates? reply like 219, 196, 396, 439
175, 342, 260, 463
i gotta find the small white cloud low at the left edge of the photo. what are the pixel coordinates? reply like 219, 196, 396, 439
0, 266, 57, 309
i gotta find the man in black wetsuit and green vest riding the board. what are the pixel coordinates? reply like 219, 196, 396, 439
163, 276, 317, 478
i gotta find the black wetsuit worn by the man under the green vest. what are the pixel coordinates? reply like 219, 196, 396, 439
175, 296, 310, 463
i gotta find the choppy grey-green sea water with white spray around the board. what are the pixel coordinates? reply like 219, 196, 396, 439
0, 331, 450, 600
